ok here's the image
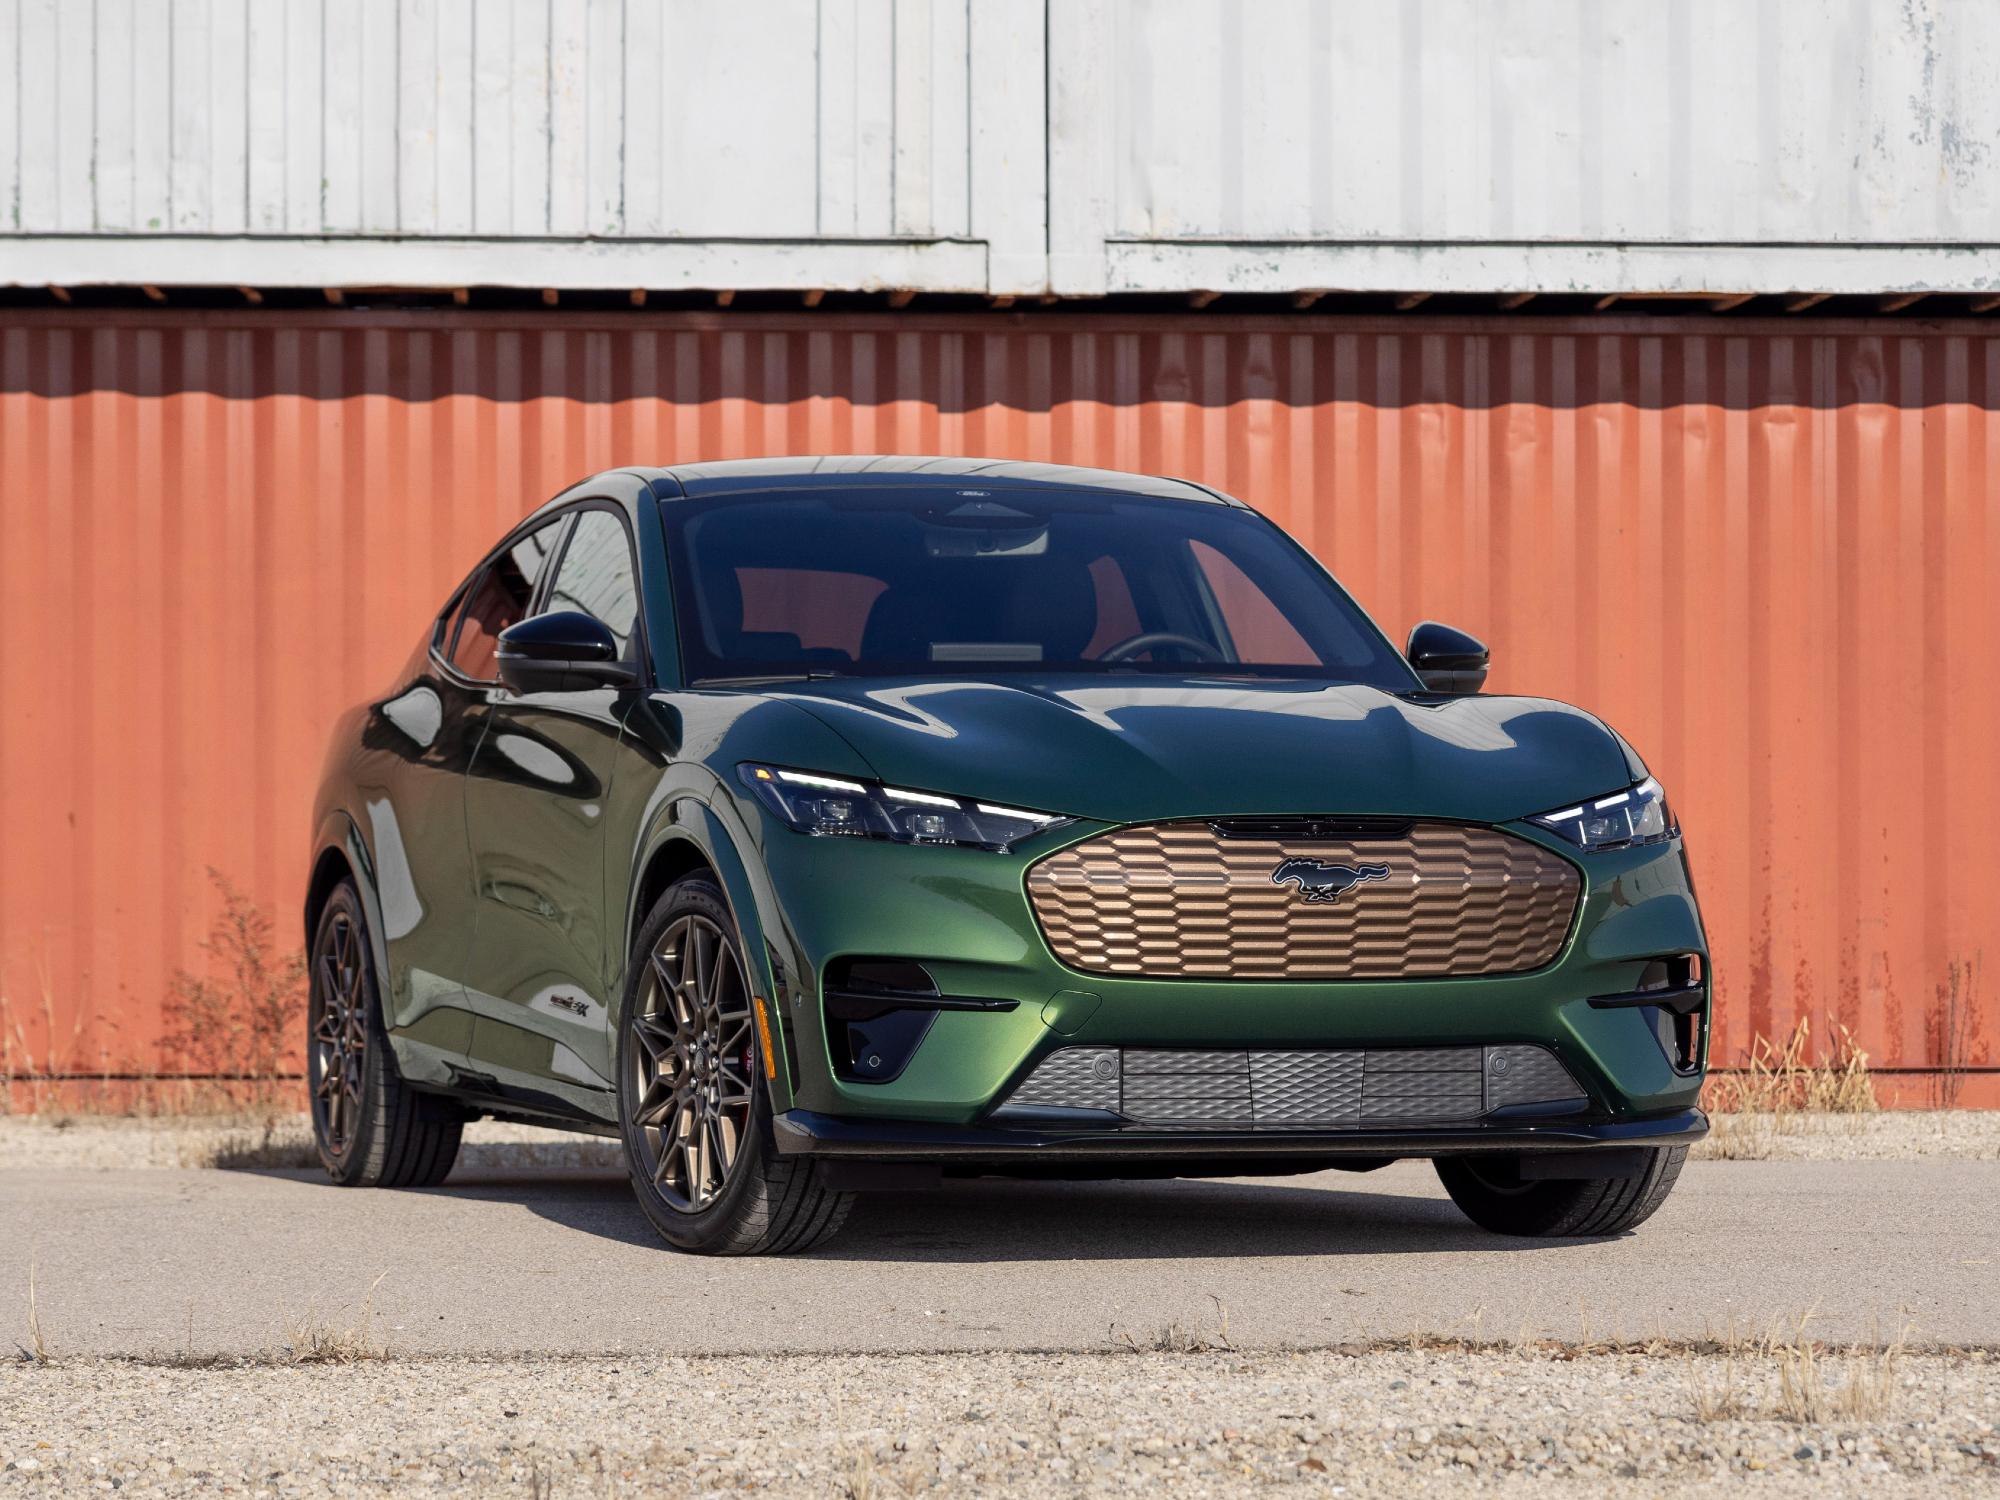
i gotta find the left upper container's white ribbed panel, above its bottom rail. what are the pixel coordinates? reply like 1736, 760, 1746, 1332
0, 0, 1000, 253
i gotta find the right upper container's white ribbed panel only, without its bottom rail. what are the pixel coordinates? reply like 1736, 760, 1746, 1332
1054, 0, 2000, 244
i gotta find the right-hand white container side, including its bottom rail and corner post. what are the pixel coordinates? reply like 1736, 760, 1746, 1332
1050, 0, 2000, 292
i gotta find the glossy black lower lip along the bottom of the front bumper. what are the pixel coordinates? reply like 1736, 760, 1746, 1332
772, 1108, 1708, 1176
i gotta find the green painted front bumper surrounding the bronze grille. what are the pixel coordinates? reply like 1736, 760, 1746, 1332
762, 828, 1706, 1128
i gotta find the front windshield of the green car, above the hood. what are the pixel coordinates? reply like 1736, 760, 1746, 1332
662, 486, 1418, 692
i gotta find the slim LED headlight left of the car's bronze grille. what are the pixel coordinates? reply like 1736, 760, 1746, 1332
736, 762, 1076, 852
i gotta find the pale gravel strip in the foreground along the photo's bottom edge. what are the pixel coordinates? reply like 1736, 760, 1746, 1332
0, 1346, 2000, 1500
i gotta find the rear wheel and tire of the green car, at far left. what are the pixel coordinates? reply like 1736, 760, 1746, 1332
306, 880, 464, 1188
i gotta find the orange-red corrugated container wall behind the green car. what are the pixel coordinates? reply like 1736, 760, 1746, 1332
0, 310, 2000, 1096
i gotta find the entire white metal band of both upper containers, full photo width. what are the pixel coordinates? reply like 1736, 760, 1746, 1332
0, 0, 2000, 294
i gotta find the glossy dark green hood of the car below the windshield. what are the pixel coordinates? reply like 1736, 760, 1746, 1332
770, 676, 1644, 822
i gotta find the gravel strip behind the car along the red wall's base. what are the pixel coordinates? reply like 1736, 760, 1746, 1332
0, 1110, 2000, 1176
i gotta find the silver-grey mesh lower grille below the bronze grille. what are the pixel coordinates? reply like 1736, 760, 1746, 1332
1006, 1046, 1586, 1130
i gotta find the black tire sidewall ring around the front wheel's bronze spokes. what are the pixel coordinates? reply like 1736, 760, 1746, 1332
616, 876, 772, 1250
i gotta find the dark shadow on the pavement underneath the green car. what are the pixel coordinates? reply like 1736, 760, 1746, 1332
428, 1174, 1622, 1264
